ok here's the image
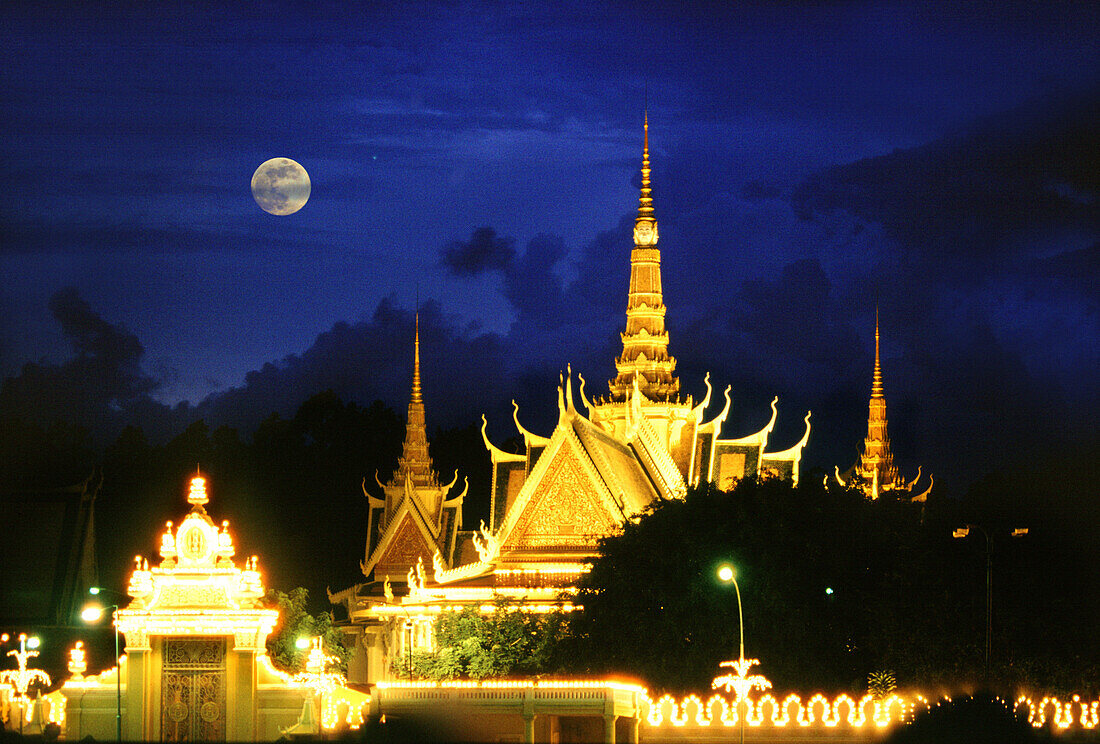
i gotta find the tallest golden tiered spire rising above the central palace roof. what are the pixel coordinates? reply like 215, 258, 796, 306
608, 111, 680, 402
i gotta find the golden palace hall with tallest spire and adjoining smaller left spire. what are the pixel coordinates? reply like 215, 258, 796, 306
330, 121, 810, 682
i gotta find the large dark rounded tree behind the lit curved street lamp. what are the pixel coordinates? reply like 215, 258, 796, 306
569, 479, 937, 691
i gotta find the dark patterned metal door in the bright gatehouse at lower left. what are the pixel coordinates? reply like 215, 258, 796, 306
161, 638, 226, 742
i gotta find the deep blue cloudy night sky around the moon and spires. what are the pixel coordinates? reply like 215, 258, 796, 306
0, 2, 1100, 483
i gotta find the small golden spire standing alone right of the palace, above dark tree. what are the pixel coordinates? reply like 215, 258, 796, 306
834, 308, 934, 501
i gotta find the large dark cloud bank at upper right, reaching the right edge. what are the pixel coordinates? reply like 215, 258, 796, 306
791, 90, 1100, 267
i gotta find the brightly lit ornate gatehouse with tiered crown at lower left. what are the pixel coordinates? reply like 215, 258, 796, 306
62, 475, 312, 742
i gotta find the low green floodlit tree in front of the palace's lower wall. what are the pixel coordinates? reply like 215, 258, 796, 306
393, 600, 567, 679
